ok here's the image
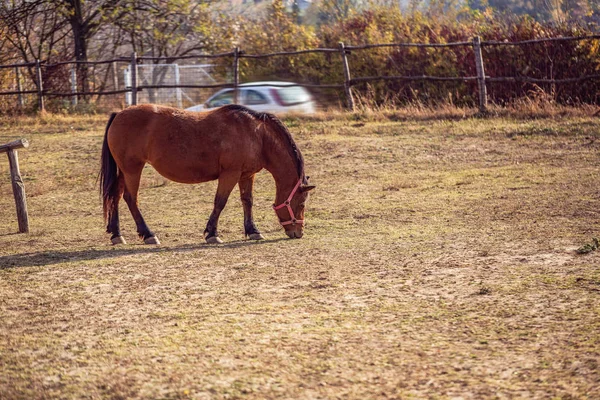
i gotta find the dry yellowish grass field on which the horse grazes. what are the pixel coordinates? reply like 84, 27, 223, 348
0, 108, 600, 399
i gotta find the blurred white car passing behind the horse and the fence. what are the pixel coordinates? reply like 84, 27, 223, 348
186, 81, 315, 114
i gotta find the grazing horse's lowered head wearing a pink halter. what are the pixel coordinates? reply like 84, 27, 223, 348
273, 178, 316, 239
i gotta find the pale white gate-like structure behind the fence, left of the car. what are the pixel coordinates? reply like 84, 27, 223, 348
124, 64, 217, 108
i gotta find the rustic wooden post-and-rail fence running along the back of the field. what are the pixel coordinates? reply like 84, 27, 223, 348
0, 35, 600, 112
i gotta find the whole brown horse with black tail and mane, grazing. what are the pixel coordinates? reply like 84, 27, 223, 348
100, 104, 315, 244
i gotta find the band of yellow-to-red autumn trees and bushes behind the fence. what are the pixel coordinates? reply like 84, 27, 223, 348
0, 0, 600, 109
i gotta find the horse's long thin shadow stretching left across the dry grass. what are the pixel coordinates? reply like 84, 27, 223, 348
0, 238, 288, 270
